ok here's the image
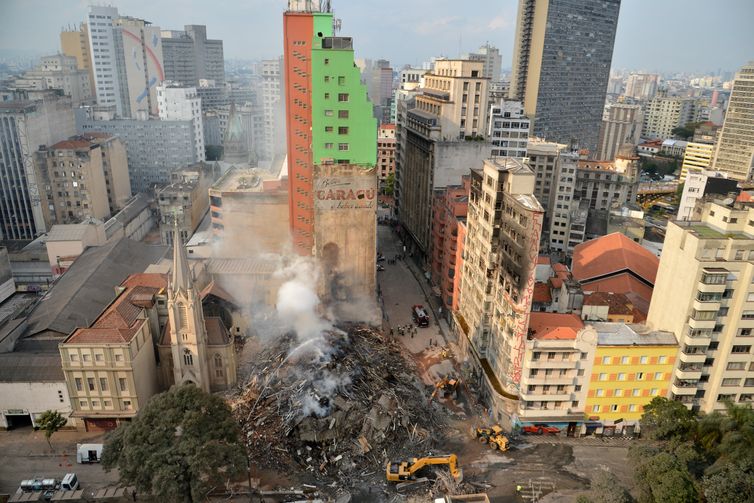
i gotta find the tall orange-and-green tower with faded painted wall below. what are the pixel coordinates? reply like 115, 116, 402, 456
283, 0, 377, 300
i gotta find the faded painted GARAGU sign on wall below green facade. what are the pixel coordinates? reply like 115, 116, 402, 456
314, 176, 377, 210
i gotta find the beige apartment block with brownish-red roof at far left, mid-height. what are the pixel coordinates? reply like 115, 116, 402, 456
39, 134, 131, 224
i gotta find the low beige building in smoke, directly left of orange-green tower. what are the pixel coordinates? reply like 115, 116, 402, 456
209, 168, 290, 258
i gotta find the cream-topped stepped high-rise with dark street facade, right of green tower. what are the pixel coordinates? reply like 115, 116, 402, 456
396, 60, 491, 258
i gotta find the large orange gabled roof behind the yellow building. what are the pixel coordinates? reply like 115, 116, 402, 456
572, 232, 660, 284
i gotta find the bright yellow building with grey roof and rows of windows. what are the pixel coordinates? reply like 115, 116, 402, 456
585, 323, 678, 432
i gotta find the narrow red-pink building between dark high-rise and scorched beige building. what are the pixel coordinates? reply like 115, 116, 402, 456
431, 177, 471, 312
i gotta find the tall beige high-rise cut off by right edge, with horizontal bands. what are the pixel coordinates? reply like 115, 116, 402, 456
712, 61, 754, 181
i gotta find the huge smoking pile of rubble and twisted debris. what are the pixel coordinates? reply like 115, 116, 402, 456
230, 325, 443, 483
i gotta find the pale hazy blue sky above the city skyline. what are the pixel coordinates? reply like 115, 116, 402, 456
0, 0, 754, 72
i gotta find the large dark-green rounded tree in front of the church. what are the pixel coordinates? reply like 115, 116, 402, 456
102, 385, 247, 502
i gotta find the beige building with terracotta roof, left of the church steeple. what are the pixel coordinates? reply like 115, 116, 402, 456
60, 274, 167, 430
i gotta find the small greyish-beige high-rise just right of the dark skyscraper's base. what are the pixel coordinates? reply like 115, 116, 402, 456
596, 103, 644, 161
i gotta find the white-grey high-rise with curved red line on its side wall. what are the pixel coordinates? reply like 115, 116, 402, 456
88, 5, 165, 117
